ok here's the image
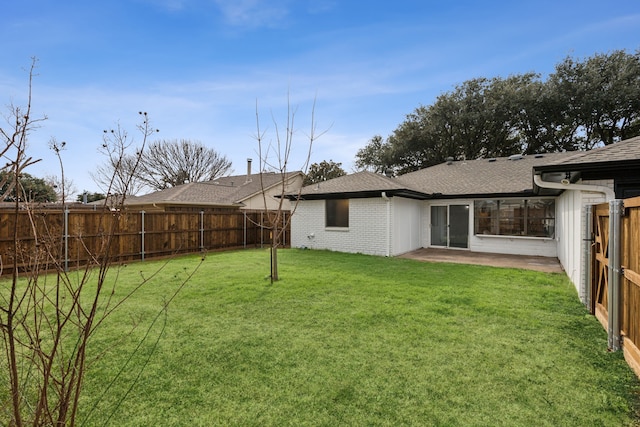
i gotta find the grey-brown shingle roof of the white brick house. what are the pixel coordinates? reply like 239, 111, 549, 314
288, 136, 640, 199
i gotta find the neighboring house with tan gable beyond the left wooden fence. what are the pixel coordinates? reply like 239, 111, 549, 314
125, 160, 303, 212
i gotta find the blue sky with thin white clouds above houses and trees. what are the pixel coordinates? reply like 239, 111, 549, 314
0, 0, 640, 196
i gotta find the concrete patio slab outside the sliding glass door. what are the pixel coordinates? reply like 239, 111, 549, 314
399, 248, 564, 273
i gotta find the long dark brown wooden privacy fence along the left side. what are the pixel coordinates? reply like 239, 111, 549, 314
0, 210, 290, 275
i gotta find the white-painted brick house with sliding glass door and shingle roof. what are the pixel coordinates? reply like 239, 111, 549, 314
288, 137, 640, 296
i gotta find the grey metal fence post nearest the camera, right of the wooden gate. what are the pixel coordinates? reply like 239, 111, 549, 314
607, 199, 623, 351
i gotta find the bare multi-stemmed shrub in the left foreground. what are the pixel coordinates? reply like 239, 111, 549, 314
0, 60, 197, 427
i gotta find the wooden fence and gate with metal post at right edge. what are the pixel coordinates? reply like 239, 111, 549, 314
591, 197, 640, 376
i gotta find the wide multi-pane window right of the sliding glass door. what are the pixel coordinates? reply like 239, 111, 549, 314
474, 199, 556, 238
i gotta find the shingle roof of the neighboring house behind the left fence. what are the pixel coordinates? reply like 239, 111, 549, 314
125, 171, 301, 207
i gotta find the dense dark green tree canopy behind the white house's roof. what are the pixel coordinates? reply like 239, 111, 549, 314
355, 50, 640, 174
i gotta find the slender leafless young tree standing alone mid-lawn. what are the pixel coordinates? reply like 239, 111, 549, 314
255, 98, 326, 283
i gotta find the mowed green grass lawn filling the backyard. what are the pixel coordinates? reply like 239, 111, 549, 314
63, 250, 640, 426
